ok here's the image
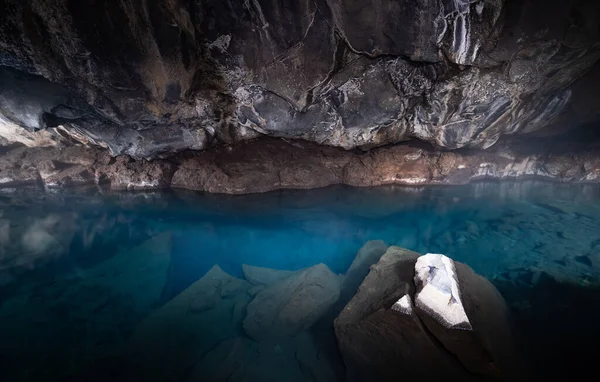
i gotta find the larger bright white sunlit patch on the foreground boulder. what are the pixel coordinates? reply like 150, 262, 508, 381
415, 253, 472, 330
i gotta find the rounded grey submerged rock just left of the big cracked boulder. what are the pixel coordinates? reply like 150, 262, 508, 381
243, 264, 340, 341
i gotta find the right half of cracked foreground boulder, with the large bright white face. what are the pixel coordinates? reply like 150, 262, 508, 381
415, 254, 526, 380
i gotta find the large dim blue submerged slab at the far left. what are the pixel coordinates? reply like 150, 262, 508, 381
0, 233, 171, 380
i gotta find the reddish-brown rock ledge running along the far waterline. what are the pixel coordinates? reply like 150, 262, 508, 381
0, 135, 600, 194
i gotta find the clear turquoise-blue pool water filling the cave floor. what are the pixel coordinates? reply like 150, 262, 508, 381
0, 182, 600, 381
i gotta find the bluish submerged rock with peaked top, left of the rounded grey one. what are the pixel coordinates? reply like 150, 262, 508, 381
127, 265, 250, 381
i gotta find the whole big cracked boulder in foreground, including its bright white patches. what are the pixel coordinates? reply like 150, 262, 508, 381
334, 247, 527, 381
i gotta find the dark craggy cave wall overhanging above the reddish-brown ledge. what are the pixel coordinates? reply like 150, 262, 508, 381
0, 0, 600, 158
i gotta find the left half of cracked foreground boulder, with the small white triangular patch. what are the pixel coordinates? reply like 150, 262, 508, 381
334, 247, 470, 382
